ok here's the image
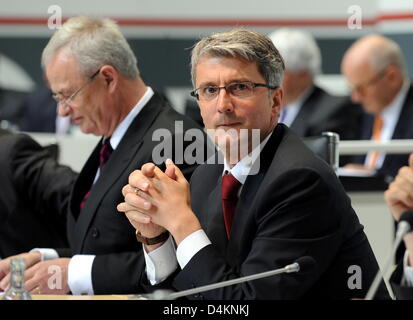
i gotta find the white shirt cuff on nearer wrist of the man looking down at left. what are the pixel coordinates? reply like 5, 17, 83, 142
67, 254, 95, 295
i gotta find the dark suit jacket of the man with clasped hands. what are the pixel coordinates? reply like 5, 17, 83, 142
167, 124, 387, 300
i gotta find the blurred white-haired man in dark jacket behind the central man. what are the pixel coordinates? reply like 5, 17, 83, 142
269, 28, 362, 140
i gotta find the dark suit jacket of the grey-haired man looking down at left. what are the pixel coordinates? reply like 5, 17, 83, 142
64, 94, 203, 294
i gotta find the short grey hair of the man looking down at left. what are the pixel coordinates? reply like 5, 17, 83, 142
42, 16, 139, 79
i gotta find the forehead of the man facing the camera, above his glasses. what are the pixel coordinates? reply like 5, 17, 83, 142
195, 56, 264, 86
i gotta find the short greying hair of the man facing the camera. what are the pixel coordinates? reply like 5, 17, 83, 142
191, 28, 284, 87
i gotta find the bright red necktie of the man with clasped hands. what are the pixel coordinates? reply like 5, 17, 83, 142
222, 173, 241, 238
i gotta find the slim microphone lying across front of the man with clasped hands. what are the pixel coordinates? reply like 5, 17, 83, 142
137, 256, 316, 300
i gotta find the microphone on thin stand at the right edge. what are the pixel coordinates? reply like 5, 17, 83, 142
365, 211, 413, 300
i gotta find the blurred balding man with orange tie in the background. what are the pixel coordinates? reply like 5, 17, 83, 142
341, 35, 413, 182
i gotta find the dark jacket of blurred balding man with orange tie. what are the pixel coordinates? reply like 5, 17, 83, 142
353, 86, 413, 181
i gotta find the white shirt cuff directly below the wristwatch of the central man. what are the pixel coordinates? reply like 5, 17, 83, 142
143, 235, 178, 285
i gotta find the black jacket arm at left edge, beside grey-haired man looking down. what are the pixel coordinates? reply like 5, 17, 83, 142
0, 130, 77, 258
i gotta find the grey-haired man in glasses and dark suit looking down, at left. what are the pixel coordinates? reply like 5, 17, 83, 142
0, 17, 201, 294
